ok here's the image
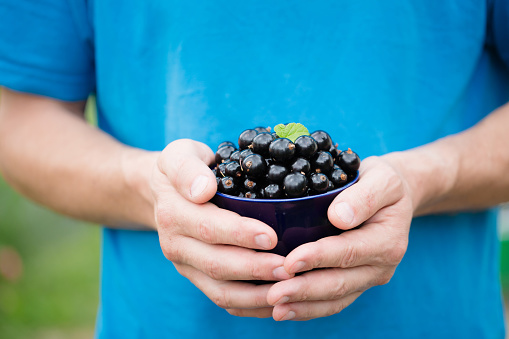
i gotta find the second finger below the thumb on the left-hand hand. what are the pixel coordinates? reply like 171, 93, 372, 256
163, 237, 292, 281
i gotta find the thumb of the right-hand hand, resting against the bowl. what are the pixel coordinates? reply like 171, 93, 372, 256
327, 157, 404, 230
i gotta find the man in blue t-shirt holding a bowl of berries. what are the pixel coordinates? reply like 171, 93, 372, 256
0, 0, 509, 338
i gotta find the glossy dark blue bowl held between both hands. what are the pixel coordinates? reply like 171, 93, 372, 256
211, 172, 359, 256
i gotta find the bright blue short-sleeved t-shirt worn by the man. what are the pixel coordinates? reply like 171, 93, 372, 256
0, 0, 509, 339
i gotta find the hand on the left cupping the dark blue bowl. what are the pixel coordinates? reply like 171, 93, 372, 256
151, 139, 293, 317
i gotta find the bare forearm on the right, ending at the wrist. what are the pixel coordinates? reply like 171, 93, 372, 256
386, 104, 509, 215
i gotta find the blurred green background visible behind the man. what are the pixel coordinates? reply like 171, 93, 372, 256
0, 96, 509, 339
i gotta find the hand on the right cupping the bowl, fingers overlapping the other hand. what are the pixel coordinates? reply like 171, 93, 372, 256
267, 157, 413, 321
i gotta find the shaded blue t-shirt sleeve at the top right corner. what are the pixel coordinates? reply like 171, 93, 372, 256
487, 0, 509, 67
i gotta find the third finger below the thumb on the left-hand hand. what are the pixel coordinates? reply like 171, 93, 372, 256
175, 265, 272, 309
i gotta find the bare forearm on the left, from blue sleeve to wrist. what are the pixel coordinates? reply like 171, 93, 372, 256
0, 90, 155, 228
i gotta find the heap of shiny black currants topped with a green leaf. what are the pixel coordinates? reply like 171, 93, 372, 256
213, 124, 360, 199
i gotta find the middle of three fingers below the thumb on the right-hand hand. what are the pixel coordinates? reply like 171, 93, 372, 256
267, 266, 382, 305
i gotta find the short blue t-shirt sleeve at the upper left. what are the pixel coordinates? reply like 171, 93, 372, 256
0, 0, 95, 101
